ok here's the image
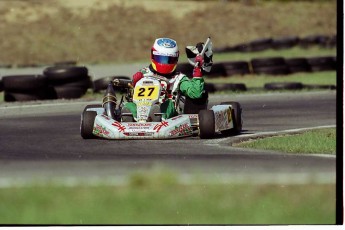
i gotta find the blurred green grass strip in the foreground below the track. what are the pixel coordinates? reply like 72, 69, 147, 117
0, 181, 336, 225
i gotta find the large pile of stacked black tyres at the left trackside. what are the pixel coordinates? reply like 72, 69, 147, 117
1, 65, 92, 102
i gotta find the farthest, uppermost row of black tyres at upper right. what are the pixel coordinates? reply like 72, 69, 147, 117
213, 35, 337, 53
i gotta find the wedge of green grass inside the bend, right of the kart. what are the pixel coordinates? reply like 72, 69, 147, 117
235, 128, 336, 155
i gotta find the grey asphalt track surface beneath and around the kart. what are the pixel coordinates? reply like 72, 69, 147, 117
0, 91, 336, 186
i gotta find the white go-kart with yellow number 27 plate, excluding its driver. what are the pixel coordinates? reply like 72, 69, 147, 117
80, 39, 242, 139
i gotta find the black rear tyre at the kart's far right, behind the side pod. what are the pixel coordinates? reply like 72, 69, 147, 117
220, 101, 243, 136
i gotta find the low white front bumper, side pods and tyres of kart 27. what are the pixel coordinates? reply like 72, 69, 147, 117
80, 102, 242, 140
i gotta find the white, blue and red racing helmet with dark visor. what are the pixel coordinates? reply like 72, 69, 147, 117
151, 38, 179, 74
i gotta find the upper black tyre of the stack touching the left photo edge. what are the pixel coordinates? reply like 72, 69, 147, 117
2, 75, 48, 92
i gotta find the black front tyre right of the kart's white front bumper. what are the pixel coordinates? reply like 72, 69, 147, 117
198, 110, 216, 139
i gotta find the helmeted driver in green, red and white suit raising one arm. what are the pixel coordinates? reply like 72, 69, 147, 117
122, 38, 204, 121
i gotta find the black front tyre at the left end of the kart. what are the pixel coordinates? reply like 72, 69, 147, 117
80, 105, 102, 139
